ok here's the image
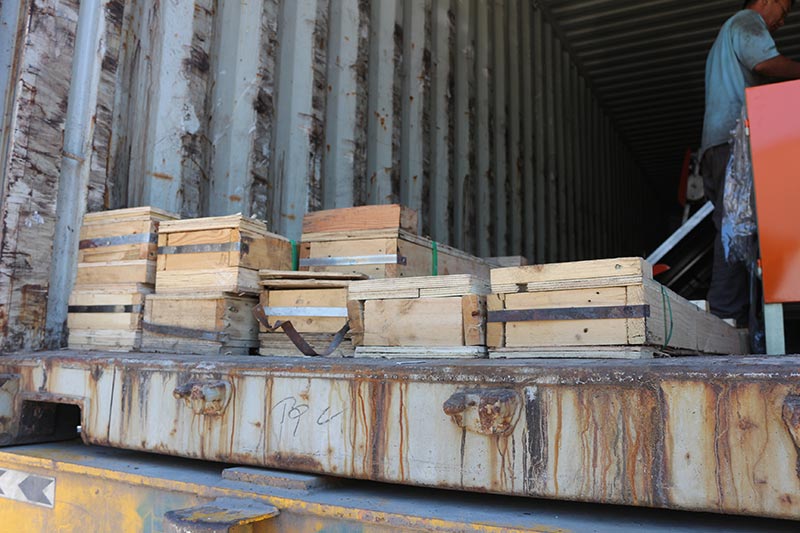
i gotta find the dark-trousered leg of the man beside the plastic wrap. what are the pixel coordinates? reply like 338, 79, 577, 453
701, 144, 750, 325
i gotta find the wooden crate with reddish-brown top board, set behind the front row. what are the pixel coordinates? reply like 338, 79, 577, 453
300, 205, 491, 279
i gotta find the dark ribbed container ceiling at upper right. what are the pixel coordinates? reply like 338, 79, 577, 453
538, 0, 800, 199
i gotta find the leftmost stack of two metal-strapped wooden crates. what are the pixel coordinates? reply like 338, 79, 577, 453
67, 207, 177, 351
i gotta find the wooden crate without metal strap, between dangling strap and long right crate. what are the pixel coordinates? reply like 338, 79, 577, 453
348, 275, 489, 358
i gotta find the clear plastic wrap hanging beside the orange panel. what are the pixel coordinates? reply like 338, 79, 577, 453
720, 109, 758, 269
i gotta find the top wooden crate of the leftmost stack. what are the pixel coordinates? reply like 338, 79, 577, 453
75, 207, 178, 287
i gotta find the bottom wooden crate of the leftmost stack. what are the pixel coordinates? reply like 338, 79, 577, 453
67, 284, 152, 351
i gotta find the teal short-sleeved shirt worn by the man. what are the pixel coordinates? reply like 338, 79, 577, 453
700, 9, 779, 157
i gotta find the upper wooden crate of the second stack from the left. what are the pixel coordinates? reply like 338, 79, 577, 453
156, 215, 292, 295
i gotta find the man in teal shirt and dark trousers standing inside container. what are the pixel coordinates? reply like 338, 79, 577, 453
700, 0, 800, 327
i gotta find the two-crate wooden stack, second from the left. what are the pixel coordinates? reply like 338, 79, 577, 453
142, 215, 292, 355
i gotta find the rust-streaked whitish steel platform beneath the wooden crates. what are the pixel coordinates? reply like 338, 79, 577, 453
0, 351, 800, 520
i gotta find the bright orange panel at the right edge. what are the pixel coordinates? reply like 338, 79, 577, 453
747, 81, 800, 303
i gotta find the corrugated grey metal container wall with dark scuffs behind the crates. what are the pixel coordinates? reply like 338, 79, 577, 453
0, 0, 644, 349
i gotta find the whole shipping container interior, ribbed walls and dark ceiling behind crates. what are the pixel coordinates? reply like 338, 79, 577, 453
0, 0, 800, 350
